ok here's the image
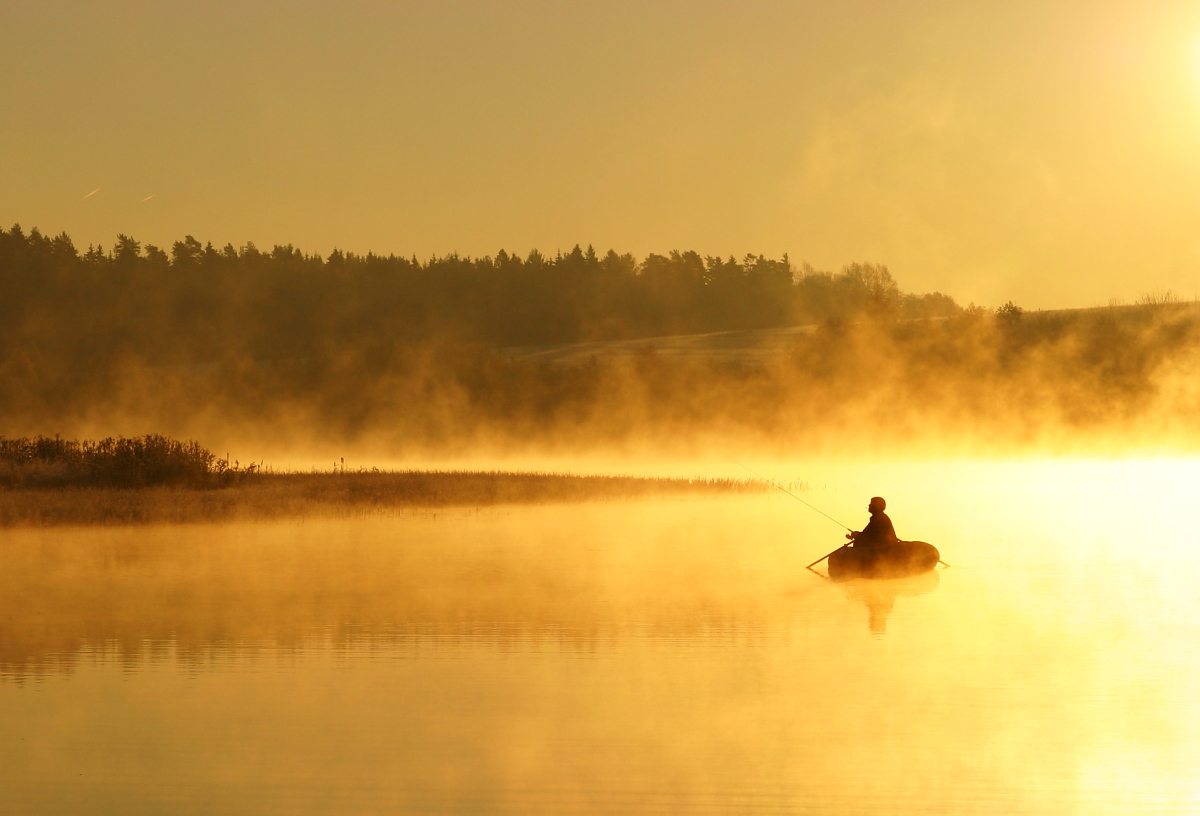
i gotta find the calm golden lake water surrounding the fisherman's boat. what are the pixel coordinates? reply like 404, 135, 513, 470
0, 461, 1200, 816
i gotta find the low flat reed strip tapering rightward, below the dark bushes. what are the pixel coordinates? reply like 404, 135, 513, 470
0, 470, 766, 527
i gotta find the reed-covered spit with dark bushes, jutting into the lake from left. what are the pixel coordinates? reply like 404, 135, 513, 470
0, 436, 762, 527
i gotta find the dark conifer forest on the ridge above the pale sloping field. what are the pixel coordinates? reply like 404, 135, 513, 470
0, 219, 961, 365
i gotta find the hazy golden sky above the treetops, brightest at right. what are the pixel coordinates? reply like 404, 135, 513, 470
0, 0, 1200, 307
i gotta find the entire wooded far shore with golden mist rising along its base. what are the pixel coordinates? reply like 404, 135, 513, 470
0, 227, 1200, 452
